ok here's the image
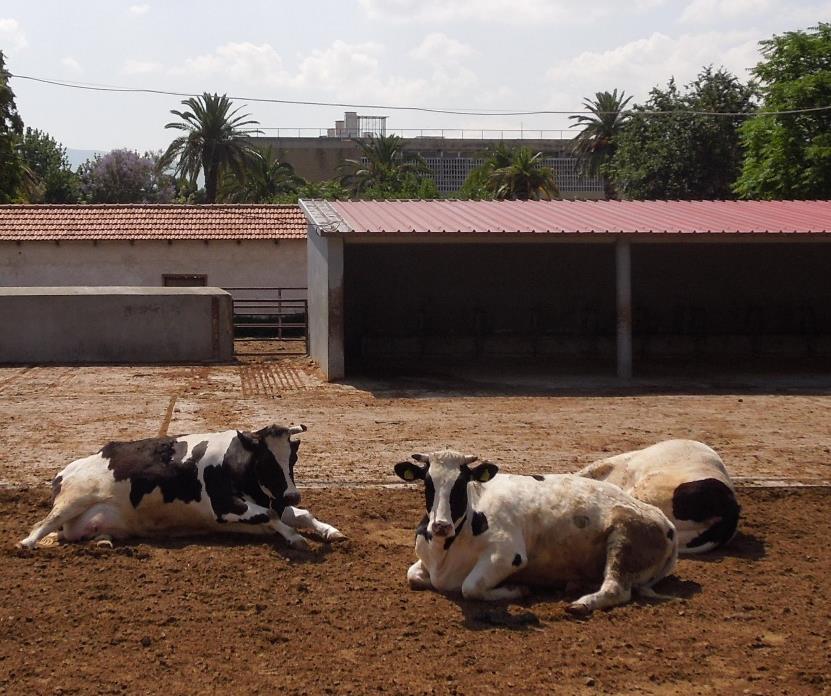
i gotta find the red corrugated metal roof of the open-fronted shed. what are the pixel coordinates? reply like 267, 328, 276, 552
320, 200, 831, 235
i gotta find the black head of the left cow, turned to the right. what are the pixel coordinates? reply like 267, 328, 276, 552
237, 425, 306, 512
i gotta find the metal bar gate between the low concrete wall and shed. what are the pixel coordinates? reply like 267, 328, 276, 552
224, 287, 309, 354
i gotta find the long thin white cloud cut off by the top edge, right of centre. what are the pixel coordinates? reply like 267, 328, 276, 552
359, 0, 666, 24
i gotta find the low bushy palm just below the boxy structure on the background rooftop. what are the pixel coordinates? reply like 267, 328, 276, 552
338, 135, 430, 196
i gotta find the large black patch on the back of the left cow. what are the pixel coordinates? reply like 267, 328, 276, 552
101, 437, 208, 508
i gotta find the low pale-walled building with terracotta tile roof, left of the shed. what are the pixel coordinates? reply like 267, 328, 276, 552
0, 204, 306, 288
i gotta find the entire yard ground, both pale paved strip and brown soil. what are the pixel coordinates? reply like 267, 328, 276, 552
0, 358, 831, 696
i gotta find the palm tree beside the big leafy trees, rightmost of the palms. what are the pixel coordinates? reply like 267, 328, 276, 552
569, 89, 632, 198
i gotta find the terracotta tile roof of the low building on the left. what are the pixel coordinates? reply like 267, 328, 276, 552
0, 204, 306, 241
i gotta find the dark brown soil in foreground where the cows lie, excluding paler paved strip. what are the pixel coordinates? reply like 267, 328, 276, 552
0, 487, 831, 694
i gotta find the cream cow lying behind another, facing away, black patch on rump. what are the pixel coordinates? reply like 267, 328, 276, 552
577, 440, 741, 553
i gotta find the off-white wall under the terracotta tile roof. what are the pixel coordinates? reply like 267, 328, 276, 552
0, 239, 306, 288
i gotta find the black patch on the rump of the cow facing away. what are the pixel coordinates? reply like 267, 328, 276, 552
672, 478, 741, 553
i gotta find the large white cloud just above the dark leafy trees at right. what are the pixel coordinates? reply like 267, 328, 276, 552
546, 31, 759, 102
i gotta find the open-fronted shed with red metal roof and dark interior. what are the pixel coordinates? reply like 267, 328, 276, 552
301, 200, 831, 379
